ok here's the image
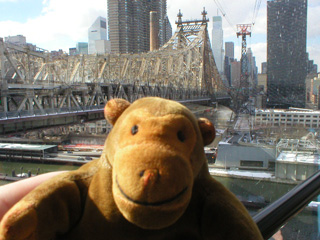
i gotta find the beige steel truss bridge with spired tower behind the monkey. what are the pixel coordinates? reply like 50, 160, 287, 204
0, 11, 229, 133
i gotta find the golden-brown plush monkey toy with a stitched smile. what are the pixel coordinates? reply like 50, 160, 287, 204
0, 97, 262, 240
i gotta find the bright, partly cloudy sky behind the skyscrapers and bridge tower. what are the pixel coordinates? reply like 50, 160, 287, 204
0, 0, 320, 71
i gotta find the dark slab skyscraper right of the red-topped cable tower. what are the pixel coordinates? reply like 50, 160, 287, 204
267, 0, 307, 108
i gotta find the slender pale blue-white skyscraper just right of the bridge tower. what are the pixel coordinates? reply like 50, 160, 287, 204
212, 16, 224, 73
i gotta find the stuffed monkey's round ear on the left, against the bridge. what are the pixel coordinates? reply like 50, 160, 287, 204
104, 98, 130, 125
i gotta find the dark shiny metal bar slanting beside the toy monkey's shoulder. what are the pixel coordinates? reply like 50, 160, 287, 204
253, 171, 320, 239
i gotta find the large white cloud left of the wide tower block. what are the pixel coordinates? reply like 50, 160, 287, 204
0, 0, 107, 51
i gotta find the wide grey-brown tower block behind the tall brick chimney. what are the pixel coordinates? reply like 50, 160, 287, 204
108, 0, 172, 53
